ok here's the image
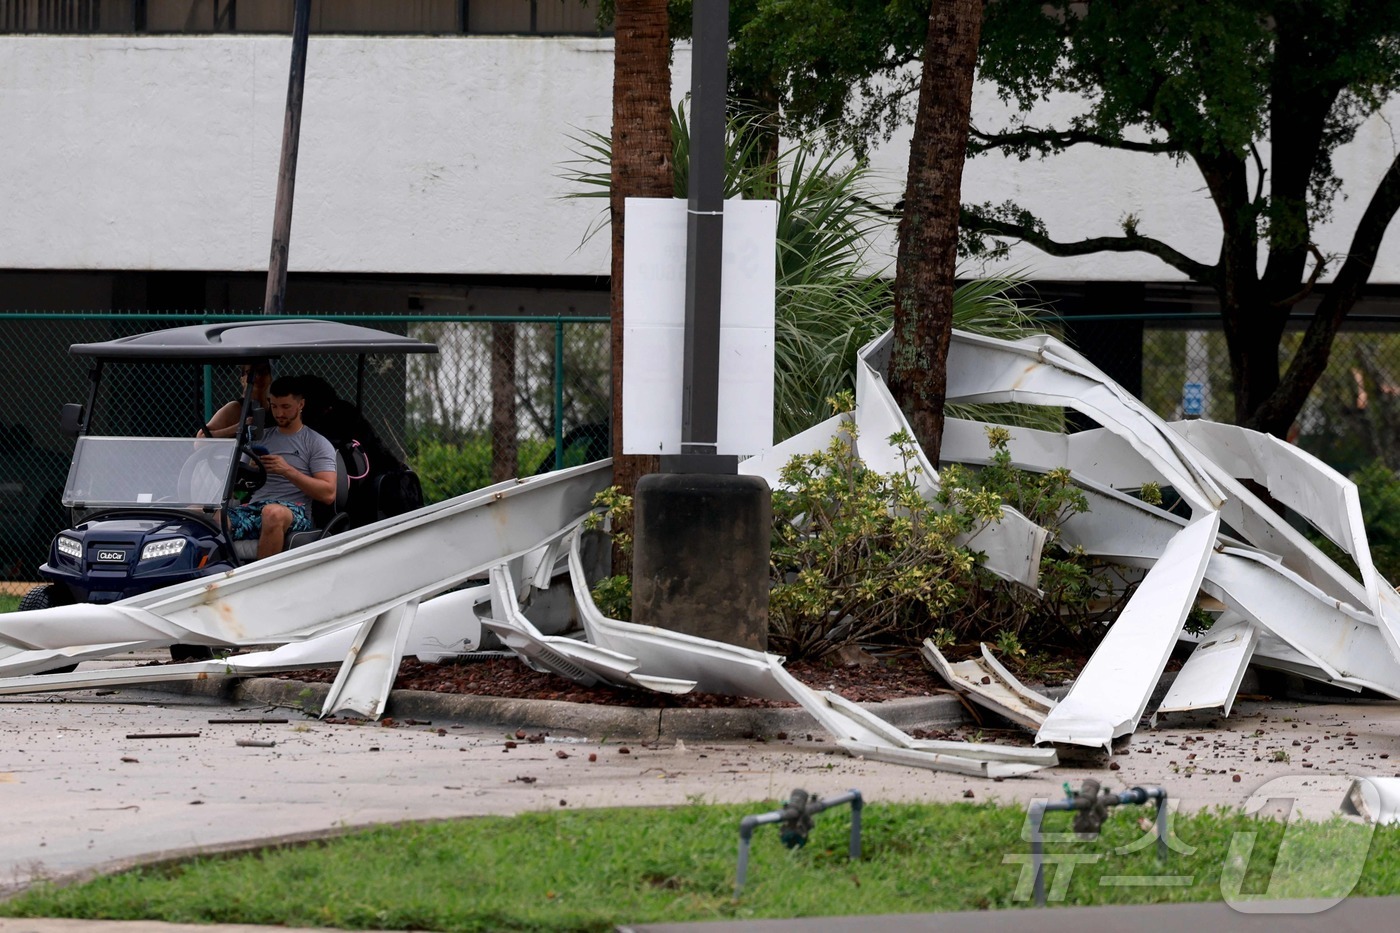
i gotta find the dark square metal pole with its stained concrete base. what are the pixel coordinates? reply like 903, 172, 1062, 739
631, 0, 773, 651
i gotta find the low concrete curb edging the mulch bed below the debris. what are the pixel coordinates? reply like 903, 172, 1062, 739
143, 677, 969, 741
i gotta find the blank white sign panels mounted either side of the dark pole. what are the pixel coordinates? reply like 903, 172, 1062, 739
622, 198, 778, 455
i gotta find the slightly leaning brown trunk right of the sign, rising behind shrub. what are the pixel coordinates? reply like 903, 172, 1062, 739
889, 0, 981, 465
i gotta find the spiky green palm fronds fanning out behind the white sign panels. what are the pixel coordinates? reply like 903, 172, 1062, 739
561, 102, 1063, 438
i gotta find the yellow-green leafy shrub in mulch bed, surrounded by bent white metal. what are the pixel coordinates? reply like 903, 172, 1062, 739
591, 403, 1124, 667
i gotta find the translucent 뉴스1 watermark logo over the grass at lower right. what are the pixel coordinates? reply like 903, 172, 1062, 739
1001, 775, 1375, 913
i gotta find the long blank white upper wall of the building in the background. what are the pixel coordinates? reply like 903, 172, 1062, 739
0, 36, 1400, 283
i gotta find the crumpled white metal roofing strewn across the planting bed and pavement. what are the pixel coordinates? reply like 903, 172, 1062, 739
8, 323, 1400, 776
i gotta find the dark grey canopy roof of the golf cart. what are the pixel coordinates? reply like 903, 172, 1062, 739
69, 318, 437, 363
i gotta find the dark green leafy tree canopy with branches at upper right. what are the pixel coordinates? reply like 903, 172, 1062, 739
711, 0, 1400, 436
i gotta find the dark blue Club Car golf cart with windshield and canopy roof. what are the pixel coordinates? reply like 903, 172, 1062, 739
21, 318, 437, 633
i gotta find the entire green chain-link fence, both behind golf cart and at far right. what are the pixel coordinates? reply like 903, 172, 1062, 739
0, 305, 1400, 580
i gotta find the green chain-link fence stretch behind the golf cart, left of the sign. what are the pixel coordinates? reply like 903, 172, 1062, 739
0, 312, 610, 580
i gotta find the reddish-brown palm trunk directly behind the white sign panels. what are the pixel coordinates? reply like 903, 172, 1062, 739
609, 0, 680, 496
